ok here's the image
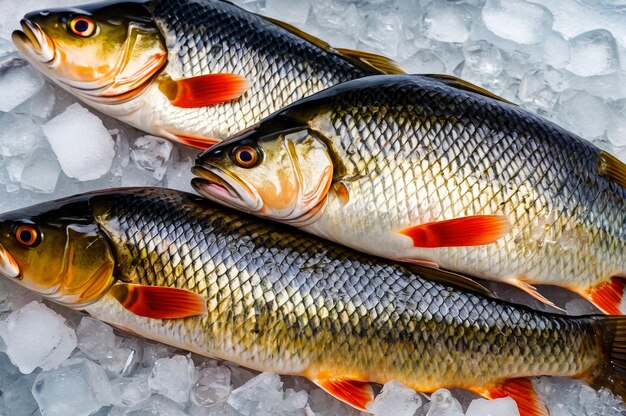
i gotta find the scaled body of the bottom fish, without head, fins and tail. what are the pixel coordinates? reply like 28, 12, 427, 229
81, 190, 600, 391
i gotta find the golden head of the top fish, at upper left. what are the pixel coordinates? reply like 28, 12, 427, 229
12, 2, 167, 104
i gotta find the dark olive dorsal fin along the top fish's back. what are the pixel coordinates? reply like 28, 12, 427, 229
259, 15, 406, 75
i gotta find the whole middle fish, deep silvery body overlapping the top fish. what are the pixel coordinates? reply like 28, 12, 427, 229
193, 75, 626, 315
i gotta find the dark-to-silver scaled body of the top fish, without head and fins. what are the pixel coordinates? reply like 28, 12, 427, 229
149, 0, 368, 137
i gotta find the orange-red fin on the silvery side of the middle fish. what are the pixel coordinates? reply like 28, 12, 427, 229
398, 215, 511, 248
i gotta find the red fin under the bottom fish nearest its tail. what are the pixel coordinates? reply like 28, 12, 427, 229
477, 378, 549, 416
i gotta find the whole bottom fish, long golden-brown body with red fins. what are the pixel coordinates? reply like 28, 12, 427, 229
0, 188, 626, 415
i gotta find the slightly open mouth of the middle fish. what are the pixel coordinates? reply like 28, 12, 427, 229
191, 166, 263, 214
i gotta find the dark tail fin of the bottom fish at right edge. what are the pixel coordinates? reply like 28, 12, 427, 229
589, 316, 626, 400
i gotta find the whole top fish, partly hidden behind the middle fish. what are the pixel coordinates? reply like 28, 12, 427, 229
12, 0, 403, 149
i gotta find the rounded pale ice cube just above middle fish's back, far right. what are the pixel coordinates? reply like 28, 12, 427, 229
556, 91, 611, 140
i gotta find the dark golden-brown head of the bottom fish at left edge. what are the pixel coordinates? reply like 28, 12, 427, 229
0, 199, 115, 307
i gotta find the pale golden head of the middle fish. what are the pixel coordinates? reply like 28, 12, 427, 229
192, 127, 333, 224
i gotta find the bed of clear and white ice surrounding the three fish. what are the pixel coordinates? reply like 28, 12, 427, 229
0, 0, 626, 416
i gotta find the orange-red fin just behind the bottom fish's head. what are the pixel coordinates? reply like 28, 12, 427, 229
111, 283, 207, 319
